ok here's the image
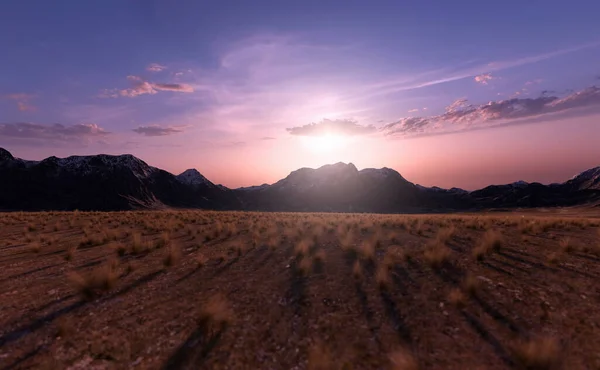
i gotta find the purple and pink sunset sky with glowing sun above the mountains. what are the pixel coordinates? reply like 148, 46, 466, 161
0, 0, 600, 190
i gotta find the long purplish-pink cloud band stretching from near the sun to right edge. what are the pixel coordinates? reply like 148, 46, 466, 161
382, 86, 600, 137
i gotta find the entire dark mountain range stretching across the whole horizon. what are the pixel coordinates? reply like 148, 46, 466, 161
0, 148, 600, 213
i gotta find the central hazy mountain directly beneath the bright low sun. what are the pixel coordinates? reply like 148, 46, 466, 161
236, 162, 466, 212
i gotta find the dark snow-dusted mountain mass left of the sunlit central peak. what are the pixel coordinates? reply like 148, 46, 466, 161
0, 149, 239, 210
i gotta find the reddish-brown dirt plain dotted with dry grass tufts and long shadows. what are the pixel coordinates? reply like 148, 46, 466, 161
0, 209, 600, 369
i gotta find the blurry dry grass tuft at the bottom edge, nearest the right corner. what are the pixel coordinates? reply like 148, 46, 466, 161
513, 338, 562, 370
